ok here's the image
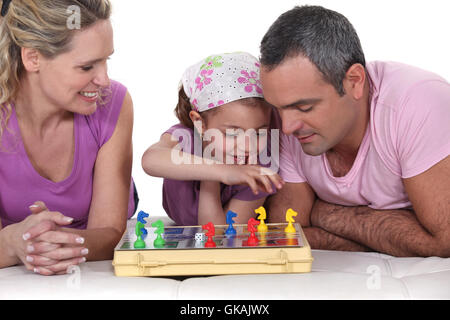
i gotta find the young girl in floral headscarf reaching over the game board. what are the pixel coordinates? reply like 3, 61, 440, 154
142, 53, 284, 225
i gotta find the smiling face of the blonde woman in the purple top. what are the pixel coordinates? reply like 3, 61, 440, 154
38, 20, 114, 115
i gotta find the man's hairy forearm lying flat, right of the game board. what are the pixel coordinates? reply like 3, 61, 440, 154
311, 200, 440, 256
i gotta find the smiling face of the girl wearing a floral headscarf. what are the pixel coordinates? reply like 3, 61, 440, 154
203, 100, 270, 164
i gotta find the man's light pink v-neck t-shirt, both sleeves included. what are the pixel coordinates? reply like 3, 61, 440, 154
280, 61, 450, 209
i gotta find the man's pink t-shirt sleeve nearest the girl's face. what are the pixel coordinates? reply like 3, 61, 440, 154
279, 132, 306, 183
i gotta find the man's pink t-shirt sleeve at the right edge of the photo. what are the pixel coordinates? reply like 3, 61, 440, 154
396, 81, 450, 178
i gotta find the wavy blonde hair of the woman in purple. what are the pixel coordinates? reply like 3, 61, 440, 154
0, 0, 111, 139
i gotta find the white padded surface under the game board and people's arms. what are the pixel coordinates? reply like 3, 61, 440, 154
0, 250, 450, 300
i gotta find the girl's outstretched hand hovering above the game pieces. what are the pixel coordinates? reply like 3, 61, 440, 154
220, 165, 285, 194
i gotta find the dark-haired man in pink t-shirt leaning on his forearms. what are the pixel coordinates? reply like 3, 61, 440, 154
261, 6, 450, 257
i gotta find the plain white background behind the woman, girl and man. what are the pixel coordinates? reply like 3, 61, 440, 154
109, 0, 450, 215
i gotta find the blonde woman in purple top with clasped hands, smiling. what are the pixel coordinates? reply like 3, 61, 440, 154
0, 0, 137, 275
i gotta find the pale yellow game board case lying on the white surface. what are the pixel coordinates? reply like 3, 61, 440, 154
113, 223, 313, 276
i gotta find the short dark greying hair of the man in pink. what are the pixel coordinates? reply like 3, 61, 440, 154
260, 6, 366, 96
